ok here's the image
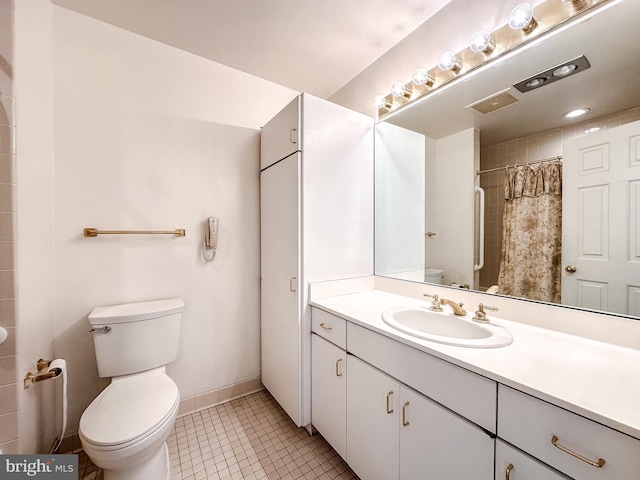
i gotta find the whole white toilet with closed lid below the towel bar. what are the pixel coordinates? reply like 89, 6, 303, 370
78, 298, 184, 480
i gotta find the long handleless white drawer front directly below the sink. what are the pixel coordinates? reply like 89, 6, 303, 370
347, 322, 497, 433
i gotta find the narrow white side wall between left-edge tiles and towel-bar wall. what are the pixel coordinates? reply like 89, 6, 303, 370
14, 0, 56, 453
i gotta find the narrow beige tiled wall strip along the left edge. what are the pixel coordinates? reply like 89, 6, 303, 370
0, 0, 18, 453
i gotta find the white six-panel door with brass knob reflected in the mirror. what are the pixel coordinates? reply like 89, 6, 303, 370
562, 122, 640, 316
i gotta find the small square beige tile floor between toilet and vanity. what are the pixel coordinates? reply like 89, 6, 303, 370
78, 390, 358, 480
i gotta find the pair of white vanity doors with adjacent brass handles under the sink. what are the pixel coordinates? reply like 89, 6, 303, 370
347, 355, 494, 480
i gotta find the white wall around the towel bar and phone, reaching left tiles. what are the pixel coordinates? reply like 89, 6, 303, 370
16, 0, 297, 453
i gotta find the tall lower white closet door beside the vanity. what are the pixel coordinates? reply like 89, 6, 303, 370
260, 153, 301, 425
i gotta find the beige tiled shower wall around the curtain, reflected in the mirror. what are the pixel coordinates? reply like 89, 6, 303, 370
480, 108, 640, 290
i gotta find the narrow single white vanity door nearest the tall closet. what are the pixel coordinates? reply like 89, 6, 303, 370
311, 333, 347, 458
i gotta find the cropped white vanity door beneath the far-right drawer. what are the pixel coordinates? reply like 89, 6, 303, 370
496, 439, 570, 480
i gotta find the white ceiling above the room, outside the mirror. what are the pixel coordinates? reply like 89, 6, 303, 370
52, 0, 450, 98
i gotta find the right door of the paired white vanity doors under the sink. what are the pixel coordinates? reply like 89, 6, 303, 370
399, 386, 495, 480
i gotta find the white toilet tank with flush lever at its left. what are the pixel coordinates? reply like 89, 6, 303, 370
89, 298, 184, 377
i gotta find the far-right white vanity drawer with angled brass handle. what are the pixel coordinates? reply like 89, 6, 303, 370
498, 385, 640, 480
